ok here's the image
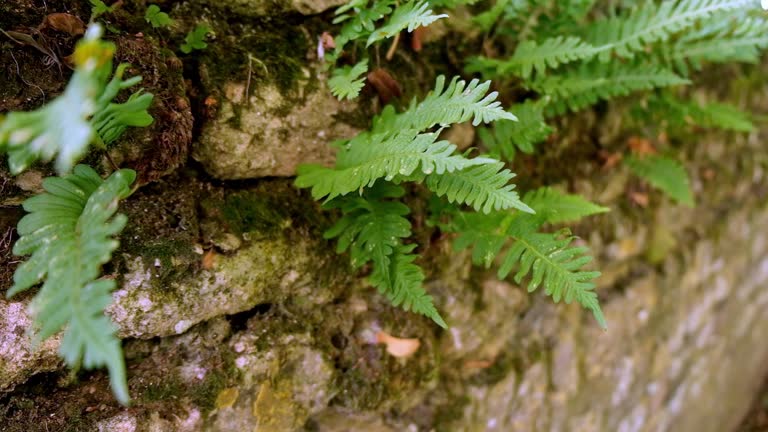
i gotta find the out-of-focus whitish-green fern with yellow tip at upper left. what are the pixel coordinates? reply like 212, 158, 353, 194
0, 25, 152, 174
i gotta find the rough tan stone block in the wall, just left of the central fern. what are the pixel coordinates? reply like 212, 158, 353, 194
193, 75, 355, 179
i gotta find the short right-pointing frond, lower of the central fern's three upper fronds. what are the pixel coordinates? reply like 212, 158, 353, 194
427, 162, 533, 213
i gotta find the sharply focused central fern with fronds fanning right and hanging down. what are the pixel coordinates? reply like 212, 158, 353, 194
296, 76, 533, 326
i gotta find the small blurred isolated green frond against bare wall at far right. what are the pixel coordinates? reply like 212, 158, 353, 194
624, 156, 694, 207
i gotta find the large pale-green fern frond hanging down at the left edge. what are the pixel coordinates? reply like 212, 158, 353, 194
8, 165, 136, 404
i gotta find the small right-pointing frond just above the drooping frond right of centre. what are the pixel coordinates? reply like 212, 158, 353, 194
523, 187, 610, 223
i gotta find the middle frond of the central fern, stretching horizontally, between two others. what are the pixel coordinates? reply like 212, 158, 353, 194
296, 129, 496, 200
